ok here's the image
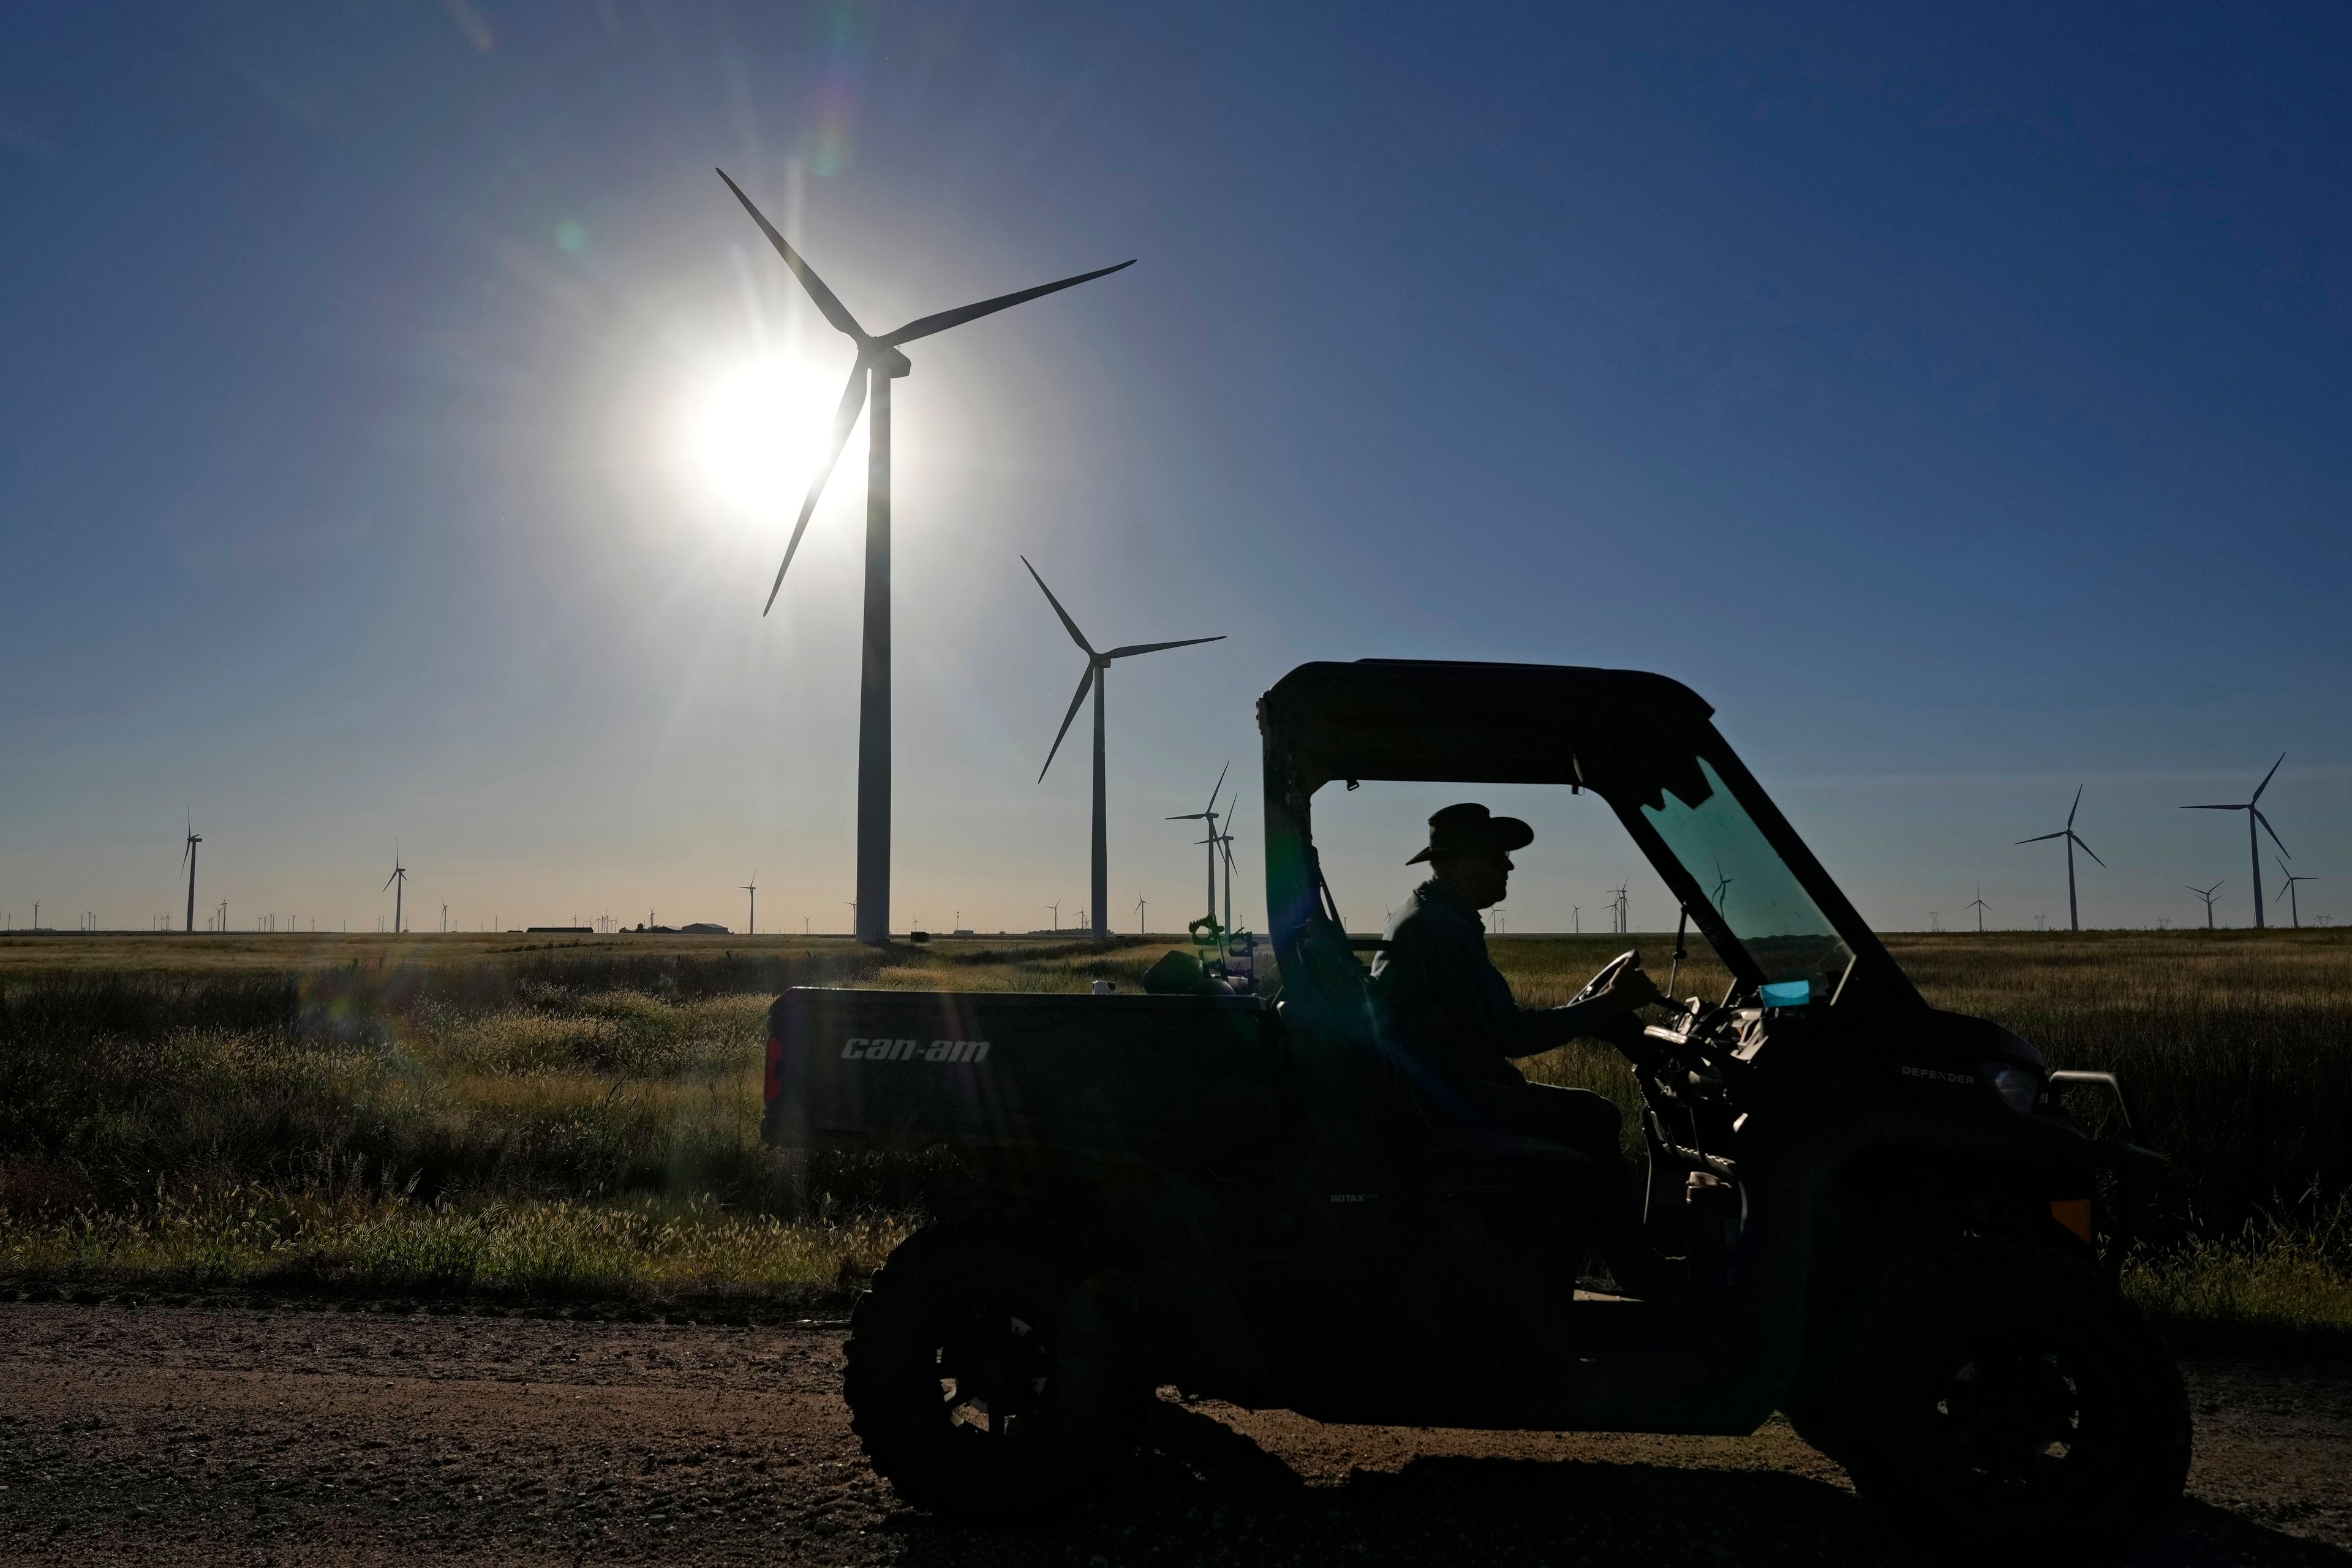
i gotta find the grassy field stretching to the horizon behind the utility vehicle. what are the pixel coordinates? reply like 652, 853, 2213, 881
0, 931, 2352, 1335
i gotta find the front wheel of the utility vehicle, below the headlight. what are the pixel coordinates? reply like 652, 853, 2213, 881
1834, 1239, 2190, 1556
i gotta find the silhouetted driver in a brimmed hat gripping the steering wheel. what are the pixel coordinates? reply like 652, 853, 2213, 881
1371, 802, 1663, 1295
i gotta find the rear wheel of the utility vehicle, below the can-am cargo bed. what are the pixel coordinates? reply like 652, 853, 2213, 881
845, 1223, 1150, 1518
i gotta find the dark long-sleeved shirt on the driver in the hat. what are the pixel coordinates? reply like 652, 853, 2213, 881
1371, 877, 1611, 1084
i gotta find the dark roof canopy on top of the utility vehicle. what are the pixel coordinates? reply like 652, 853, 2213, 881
1258, 658, 1714, 794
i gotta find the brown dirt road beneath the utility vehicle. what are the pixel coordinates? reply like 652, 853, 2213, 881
0, 1302, 2352, 1568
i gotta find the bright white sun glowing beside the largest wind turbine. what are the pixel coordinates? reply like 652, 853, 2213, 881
677, 355, 840, 524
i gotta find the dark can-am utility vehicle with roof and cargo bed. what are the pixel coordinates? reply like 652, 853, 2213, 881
767, 661, 2190, 1551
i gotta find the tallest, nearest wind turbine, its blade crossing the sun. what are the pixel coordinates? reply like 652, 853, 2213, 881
717, 169, 1134, 948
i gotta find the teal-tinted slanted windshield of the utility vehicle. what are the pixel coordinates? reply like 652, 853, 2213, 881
1642, 757, 1853, 1006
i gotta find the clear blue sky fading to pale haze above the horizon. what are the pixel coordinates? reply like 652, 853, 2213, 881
0, 0, 2352, 931
